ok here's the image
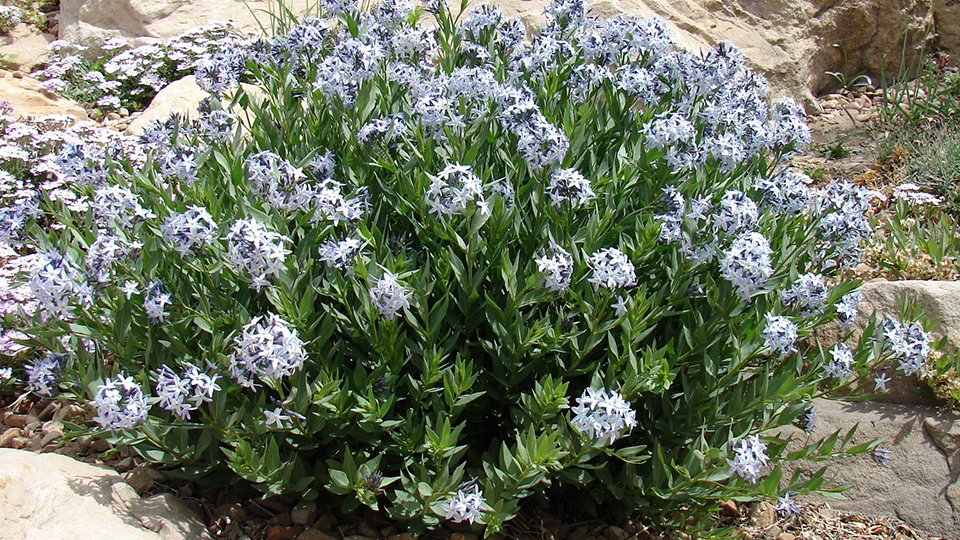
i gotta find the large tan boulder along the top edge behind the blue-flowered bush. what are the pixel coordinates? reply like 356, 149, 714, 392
60, 0, 944, 109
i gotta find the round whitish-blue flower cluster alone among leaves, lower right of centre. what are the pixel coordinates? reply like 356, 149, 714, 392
570, 388, 637, 446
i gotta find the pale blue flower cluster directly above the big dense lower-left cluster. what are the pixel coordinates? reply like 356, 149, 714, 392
225, 218, 290, 291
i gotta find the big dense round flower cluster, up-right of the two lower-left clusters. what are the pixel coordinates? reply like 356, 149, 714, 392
229, 313, 307, 388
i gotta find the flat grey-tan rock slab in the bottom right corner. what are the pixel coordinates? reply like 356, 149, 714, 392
782, 400, 960, 538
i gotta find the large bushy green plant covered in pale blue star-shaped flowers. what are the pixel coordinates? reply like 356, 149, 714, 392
5, 0, 929, 534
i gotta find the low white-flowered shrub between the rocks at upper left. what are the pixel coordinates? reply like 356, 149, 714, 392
34, 23, 255, 111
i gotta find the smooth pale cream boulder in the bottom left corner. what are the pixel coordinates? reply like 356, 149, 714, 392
0, 448, 211, 540
